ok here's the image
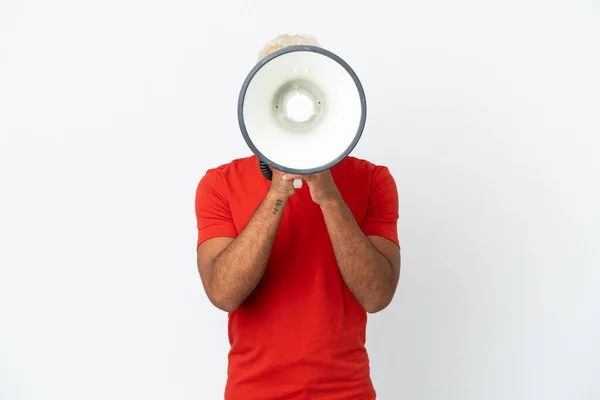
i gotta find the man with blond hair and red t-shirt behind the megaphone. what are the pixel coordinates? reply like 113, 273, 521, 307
196, 35, 400, 400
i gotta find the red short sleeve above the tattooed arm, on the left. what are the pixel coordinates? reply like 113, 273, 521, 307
196, 170, 237, 248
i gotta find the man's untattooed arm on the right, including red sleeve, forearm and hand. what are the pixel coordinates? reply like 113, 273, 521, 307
283, 168, 400, 313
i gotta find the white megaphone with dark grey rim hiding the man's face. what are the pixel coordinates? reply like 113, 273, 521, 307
238, 45, 367, 188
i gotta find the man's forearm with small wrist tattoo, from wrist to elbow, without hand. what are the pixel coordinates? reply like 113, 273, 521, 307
209, 192, 286, 312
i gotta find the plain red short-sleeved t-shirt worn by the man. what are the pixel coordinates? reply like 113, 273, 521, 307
196, 156, 398, 400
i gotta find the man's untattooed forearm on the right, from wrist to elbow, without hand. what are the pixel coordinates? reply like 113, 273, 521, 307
321, 198, 394, 312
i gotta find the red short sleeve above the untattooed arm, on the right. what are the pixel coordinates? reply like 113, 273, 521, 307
361, 166, 400, 246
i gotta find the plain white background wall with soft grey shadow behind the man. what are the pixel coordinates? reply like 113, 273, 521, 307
0, 0, 600, 400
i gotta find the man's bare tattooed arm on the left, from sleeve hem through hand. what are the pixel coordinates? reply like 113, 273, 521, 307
197, 172, 293, 312
